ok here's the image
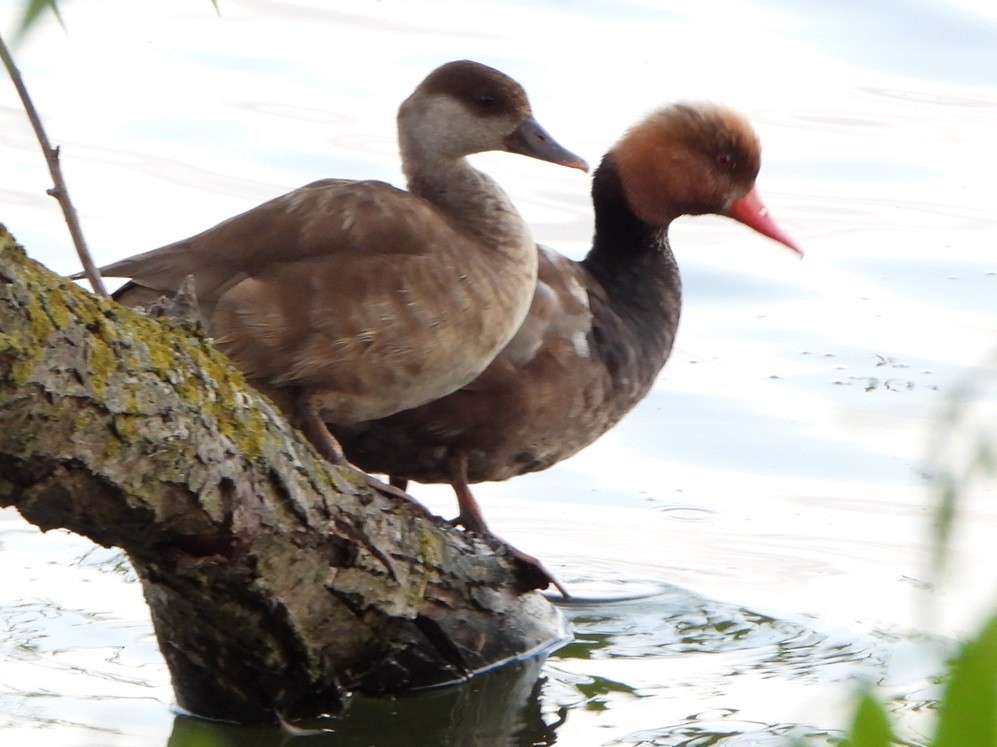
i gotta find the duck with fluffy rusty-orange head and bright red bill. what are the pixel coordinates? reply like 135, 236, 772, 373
333, 102, 802, 596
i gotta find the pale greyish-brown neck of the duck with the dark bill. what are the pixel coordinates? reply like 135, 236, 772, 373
402, 147, 535, 254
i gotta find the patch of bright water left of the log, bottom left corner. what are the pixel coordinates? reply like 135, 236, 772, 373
0, 528, 172, 746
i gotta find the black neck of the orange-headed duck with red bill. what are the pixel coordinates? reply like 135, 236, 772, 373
583, 154, 682, 374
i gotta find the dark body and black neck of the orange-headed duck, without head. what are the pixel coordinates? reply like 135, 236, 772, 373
334, 159, 681, 482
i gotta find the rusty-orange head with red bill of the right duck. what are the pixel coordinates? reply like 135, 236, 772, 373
612, 103, 803, 256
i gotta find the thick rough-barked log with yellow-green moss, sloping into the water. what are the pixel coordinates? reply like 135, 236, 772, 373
0, 226, 564, 721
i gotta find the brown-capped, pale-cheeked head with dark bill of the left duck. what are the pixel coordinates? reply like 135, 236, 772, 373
398, 60, 588, 171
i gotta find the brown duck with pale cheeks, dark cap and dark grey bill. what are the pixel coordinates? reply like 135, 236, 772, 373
85, 60, 588, 464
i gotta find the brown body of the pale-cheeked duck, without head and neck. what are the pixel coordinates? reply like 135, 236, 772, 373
109, 175, 533, 421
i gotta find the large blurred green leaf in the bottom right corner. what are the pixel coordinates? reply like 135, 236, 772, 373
931, 615, 997, 747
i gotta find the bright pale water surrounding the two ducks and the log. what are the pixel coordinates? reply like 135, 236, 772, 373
0, 0, 997, 747
